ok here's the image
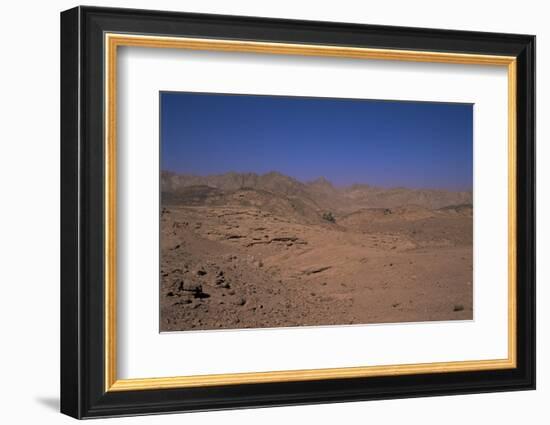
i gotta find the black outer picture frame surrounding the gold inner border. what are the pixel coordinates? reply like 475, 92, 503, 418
61, 7, 535, 418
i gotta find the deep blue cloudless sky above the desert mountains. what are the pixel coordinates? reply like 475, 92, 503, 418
160, 92, 473, 190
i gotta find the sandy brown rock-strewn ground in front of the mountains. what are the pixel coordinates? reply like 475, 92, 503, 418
160, 195, 473, 331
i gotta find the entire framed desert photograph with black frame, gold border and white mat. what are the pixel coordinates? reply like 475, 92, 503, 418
61, 7, 535, 418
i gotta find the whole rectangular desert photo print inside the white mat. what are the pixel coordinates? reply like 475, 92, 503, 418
160, 92, 473, 331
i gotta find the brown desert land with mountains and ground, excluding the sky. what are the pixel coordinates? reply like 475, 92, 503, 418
160, 171, 473, 332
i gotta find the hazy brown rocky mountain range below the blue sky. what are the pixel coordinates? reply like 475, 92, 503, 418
161, 171, 472, 212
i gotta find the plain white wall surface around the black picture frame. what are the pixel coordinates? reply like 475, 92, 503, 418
0, 0, 550, 425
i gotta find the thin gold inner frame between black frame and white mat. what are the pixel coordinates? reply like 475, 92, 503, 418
104, 33, 517, 391
